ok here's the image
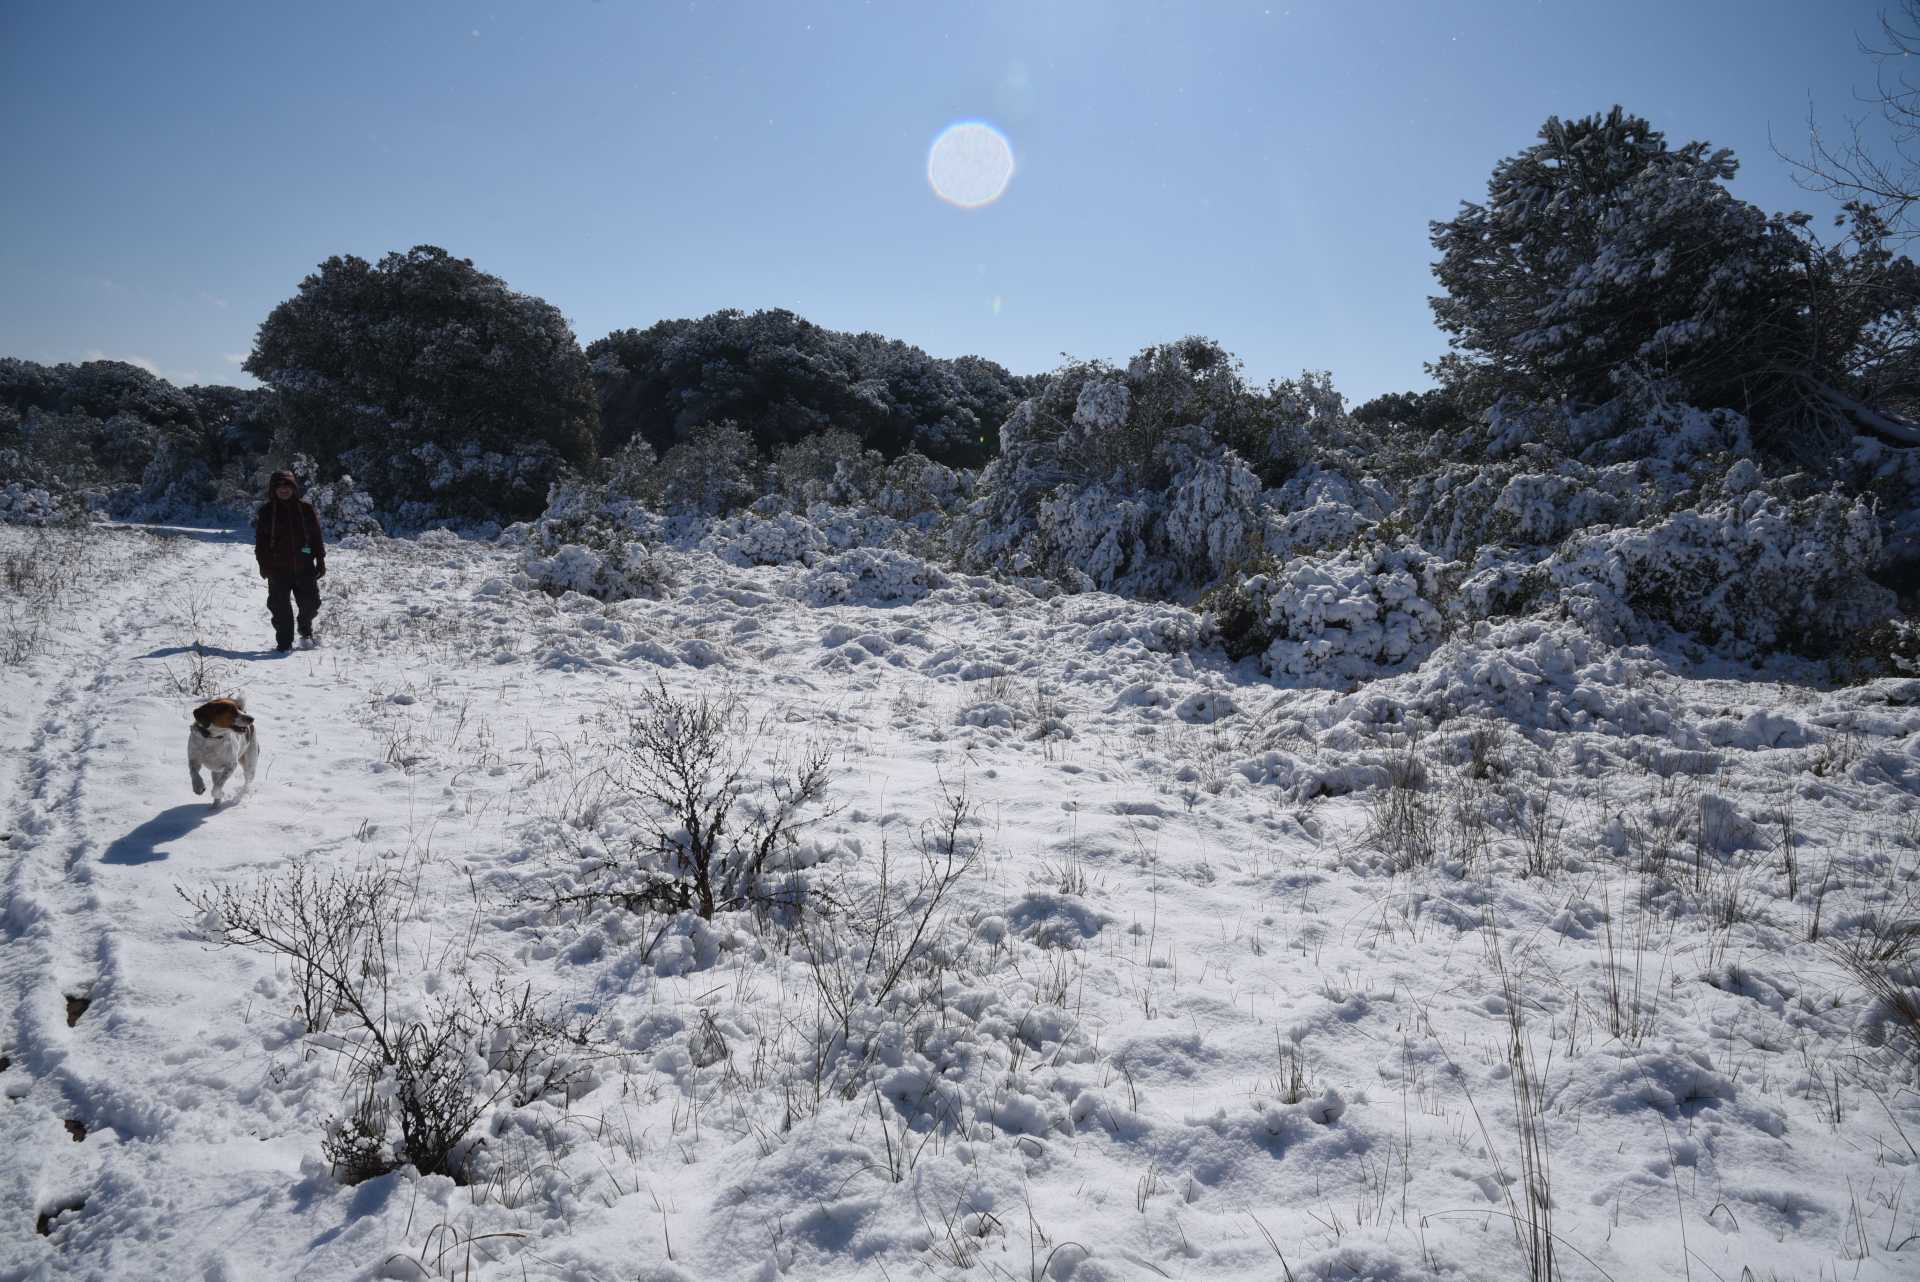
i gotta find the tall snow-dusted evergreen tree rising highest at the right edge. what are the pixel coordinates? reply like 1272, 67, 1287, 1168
1430, 107, 1920, 457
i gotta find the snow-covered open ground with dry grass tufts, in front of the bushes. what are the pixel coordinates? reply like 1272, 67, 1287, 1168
0, 530, 1920, 1282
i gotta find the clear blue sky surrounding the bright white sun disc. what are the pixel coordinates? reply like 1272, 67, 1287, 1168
0, 0, 1880, 399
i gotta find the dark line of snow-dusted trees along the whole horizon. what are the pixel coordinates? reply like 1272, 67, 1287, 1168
0, 97, 1920, 533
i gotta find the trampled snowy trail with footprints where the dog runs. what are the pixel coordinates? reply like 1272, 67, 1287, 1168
0, 534, 393, 1278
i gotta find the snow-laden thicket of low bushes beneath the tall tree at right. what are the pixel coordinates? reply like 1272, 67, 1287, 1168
1208, 405, 1903, 667
